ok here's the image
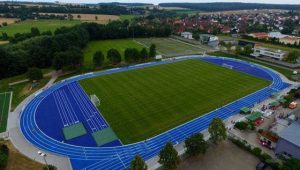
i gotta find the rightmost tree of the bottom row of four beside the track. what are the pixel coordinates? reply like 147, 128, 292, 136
208, 117, 227, 143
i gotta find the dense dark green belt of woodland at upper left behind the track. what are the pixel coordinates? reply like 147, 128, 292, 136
0, 21, 171, 79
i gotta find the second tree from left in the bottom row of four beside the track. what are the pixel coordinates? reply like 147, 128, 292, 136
158, 142, 180, 169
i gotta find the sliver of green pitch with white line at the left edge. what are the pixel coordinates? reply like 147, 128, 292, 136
0, 92, 11, 132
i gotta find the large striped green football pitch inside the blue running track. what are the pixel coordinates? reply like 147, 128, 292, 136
80, 60, 270, 144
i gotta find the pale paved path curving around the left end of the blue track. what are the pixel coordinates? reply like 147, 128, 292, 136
7, 72, 71, 170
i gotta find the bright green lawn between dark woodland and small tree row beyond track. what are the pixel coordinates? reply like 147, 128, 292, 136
83, 39, 144, 66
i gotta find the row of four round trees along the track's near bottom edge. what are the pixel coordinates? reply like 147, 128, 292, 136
130, 118, 227, 170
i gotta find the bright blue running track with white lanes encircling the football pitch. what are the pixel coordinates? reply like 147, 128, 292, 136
20, 56, 290, 170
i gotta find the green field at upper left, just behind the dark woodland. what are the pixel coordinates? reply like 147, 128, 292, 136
0, 20, 81, 36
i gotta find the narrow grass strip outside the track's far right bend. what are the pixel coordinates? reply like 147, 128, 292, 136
208, 51, 293, 79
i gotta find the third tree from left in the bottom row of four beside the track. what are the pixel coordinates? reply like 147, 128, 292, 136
184, 133, 208, 156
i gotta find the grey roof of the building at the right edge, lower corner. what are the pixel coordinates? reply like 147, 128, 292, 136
278, 121, 300, 147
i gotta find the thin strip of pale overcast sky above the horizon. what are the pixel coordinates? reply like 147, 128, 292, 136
10, 0, 300, 4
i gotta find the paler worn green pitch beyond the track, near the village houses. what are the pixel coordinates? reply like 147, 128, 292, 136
136, 38, 205, 57
